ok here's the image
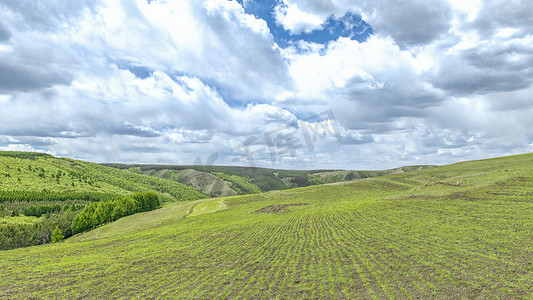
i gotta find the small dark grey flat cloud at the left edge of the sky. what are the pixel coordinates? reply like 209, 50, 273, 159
0, 60, 72, 93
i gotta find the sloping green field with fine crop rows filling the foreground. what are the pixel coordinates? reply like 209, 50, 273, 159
0, 154, 533, 299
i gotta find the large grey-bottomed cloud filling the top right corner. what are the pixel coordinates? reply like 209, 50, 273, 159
430, 0, 533, 96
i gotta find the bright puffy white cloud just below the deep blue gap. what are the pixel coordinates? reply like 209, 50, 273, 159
285, 37, 444, 128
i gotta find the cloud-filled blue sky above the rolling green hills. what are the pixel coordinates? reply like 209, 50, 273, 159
0, 0, 533, 169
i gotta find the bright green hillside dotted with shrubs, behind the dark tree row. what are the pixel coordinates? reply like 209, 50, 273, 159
0, 151, 206, 202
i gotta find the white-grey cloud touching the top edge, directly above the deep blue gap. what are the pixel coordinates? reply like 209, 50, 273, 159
275, 0, 452, 47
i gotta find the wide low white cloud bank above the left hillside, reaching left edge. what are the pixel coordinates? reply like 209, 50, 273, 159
0, 63, 296, 164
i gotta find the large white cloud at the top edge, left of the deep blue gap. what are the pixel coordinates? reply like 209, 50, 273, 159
71, 1, 291, 99
